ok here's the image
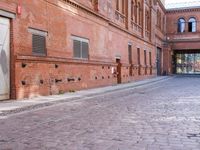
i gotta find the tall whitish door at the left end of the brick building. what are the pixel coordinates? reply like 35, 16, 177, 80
0, 17, 10, 100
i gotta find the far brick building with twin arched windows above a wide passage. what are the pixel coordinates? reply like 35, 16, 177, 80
163, 6, 200, 74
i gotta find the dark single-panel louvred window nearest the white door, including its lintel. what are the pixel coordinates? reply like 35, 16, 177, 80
28, 28, 48, 56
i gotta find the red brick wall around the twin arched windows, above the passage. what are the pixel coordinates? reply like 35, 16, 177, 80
165, 8, 200, 73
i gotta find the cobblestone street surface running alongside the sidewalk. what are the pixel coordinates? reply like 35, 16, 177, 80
0, 77, 200, 150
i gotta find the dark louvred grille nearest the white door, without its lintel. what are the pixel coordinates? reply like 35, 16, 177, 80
32, 34, 46, 55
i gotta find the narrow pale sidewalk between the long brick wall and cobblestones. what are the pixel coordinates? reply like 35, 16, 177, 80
0, 76, 172, 116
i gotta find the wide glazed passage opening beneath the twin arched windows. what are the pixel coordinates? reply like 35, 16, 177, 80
174, 50, 200, 74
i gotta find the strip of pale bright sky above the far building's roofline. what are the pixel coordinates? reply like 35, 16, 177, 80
166, 0, 200, 8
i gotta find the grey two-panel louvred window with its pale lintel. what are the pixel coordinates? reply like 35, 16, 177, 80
72, 37, 89, 59
